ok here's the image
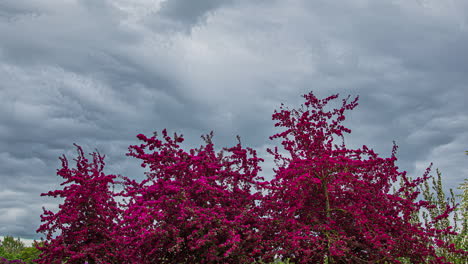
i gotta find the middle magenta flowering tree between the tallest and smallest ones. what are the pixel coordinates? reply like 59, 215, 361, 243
119, 130, 262, 264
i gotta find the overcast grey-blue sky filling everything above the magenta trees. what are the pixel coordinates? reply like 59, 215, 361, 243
0, 0, 468, 245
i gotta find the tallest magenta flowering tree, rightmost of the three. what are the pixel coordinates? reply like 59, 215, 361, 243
263, 93, 464, 263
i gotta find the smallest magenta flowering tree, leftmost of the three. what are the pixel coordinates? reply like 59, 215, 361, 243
37, 145, 120, 264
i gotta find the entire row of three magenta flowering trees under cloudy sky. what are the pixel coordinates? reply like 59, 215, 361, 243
38, 93, 466, 264
